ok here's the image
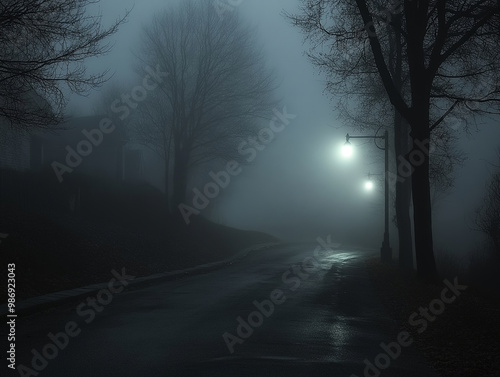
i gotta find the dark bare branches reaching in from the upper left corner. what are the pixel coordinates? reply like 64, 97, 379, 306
0, 0, 128, 130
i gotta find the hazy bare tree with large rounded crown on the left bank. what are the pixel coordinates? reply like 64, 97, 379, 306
134, 0, 275, 217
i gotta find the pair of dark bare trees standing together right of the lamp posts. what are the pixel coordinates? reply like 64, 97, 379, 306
286, 0, 500, 278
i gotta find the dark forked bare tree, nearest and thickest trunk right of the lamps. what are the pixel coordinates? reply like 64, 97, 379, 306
290, 0, 500, 277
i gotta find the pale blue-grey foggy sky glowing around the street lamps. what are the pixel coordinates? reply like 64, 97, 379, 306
64, 0, 500, 253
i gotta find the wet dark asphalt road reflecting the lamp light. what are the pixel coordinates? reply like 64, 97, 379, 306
5, 244, 435, 377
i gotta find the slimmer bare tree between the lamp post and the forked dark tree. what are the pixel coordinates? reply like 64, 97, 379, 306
286, 1, 462, 269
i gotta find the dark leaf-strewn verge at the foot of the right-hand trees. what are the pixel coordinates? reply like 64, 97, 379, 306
369, 259, 500, 377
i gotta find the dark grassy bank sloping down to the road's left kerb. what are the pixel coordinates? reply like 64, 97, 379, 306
0, 205, 276, 302
